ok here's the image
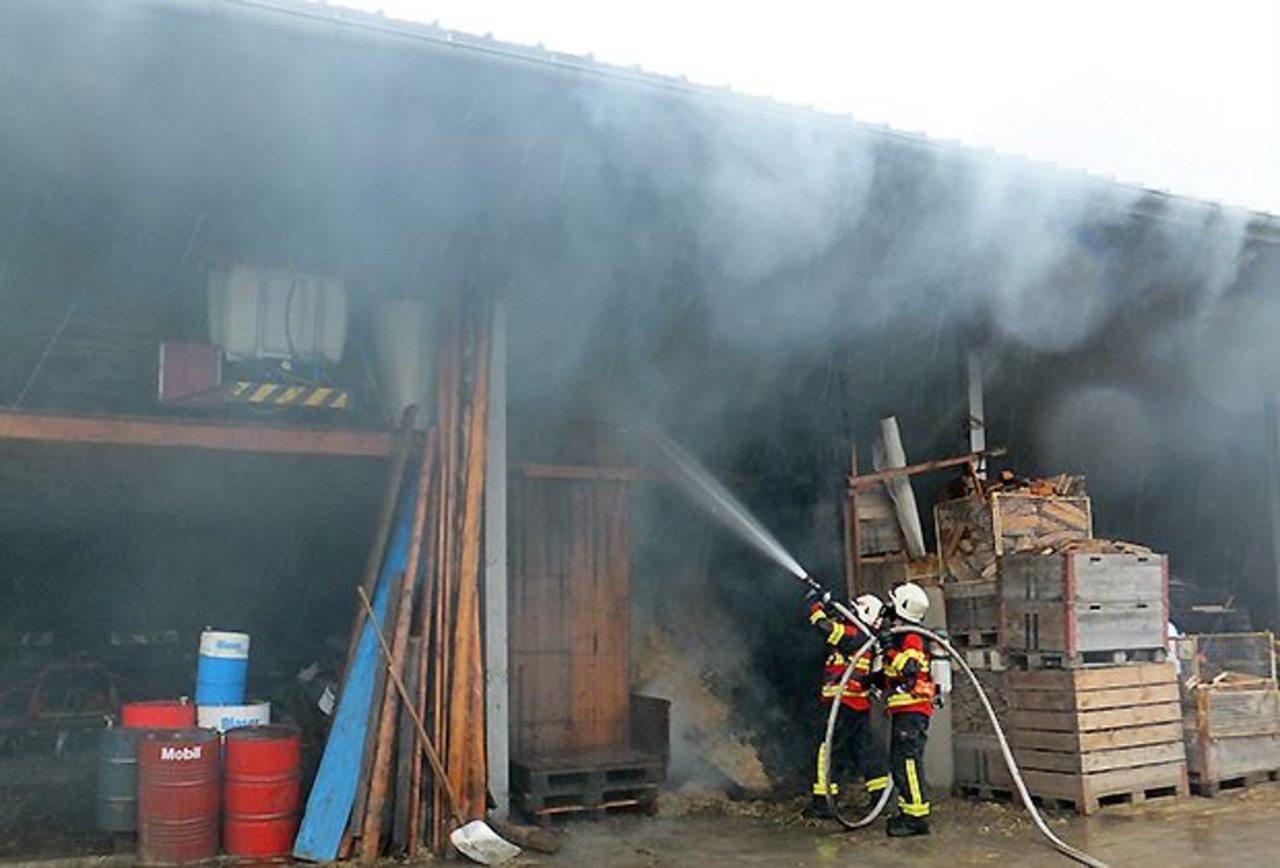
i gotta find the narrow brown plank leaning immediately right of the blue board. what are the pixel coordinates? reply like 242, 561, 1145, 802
360, 428, 436, 863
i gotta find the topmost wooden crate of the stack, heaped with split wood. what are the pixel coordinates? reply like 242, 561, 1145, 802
933, 492, 1093, 583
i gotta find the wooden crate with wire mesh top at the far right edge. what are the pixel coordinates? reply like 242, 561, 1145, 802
1178, 632, 1280, 796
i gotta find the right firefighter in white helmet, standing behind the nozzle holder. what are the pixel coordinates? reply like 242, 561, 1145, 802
879, 583, 937, 837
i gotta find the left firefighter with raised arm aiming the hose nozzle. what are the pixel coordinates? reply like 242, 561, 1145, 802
809, 593, 890, 817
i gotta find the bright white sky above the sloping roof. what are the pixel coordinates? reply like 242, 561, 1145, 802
330, 0, 1280, 214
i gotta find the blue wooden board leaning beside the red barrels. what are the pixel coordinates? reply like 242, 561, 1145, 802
293, 483, 416, 862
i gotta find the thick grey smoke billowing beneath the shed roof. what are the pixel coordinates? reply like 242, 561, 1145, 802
0, 3, 1280, 803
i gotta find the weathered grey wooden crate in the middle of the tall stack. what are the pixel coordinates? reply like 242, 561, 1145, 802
1000, 553, 1169, 667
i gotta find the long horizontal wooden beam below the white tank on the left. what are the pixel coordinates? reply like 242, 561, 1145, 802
0, 411, 394, 458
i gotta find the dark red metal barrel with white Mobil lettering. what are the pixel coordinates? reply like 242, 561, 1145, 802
138, 728, 220, 865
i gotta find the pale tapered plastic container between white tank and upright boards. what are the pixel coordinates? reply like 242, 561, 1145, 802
374, 301, 435, 429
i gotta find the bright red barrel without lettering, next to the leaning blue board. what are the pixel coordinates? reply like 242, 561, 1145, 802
223, 726, 302, 858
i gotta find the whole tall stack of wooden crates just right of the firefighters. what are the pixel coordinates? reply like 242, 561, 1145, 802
936, 492, 1187, 813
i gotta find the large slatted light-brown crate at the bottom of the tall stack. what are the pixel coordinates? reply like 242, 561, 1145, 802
1005, 663, 1188, 814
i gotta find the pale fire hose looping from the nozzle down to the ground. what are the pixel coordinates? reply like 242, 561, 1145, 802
801, 588, 1108, 868
